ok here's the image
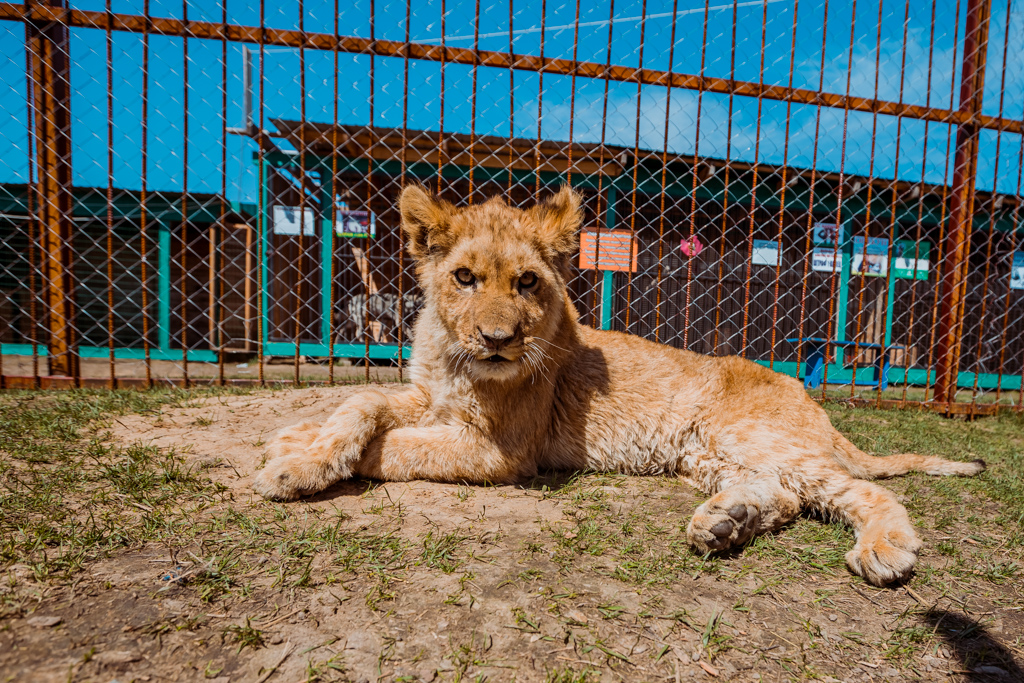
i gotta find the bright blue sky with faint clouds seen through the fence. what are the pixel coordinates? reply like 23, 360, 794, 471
0, 0, 1024, 200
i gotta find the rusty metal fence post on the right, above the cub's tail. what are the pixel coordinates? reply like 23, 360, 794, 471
935, 0, 991, 402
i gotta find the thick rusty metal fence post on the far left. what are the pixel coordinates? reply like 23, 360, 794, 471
26, 0, 79, 378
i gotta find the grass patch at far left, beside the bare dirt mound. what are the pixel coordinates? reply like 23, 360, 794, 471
0, 389, 234, 580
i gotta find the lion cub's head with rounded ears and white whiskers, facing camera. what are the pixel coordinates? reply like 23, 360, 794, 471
401, 186, 581, 381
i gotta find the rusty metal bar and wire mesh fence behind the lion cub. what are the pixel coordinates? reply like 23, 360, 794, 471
0, 0, 1024, 412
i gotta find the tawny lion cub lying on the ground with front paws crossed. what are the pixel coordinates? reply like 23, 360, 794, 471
254, 186, 984, 585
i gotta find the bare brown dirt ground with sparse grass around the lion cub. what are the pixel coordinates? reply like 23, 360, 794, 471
0, 386, 1024, 683
